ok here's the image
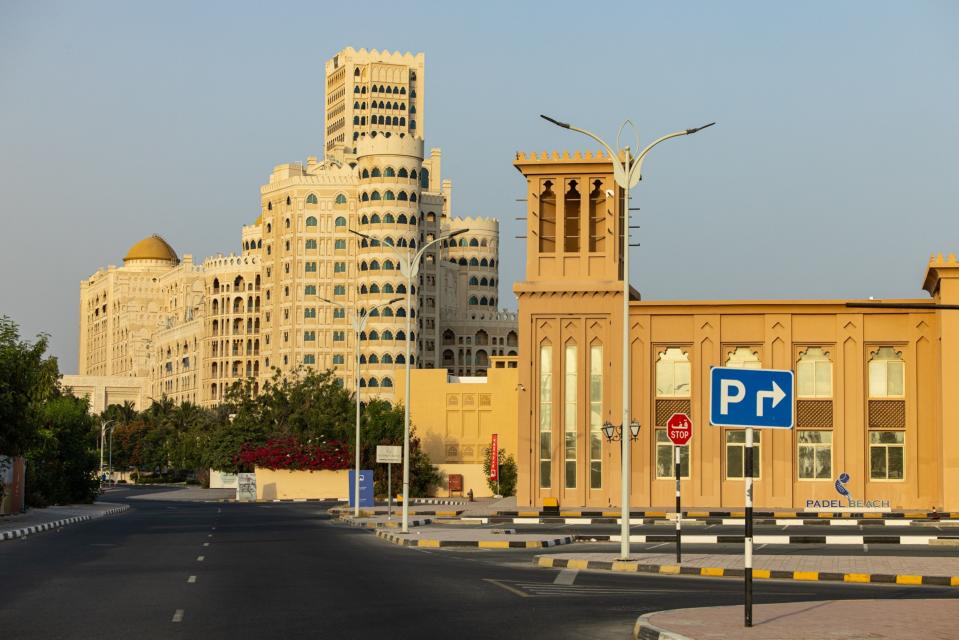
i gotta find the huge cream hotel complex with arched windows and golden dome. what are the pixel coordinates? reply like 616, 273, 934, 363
64, 48, 518, 410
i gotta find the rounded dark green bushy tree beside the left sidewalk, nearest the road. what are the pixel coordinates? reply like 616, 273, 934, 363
26, 395, 98, 507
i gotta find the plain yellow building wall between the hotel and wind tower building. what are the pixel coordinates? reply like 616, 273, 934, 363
396, 356, 519, 497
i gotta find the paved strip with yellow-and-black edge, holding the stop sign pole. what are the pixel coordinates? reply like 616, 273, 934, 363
535, 553, 959, 587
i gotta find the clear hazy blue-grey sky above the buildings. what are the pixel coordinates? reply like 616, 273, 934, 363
0, 0, 959, 373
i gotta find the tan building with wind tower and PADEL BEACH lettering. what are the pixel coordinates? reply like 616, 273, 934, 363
514, 149, 959, 510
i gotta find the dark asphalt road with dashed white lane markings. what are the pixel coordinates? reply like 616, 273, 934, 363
0, 491, 954, 640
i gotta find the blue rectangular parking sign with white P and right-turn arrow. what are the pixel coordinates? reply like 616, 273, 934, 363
709, 367, 794, 429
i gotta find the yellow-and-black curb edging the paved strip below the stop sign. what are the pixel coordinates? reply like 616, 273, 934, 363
534, 556, 959, 587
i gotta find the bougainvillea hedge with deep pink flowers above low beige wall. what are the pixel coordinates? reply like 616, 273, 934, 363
236, 437, 352, 471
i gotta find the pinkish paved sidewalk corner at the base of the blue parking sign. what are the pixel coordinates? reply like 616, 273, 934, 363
633, 599, 959, 640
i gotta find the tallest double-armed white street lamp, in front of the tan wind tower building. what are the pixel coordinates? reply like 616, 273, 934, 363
540, 115, 716, 560
